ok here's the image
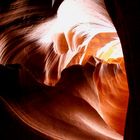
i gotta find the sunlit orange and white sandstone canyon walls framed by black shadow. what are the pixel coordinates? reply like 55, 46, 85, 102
0, 0, 129, 140
